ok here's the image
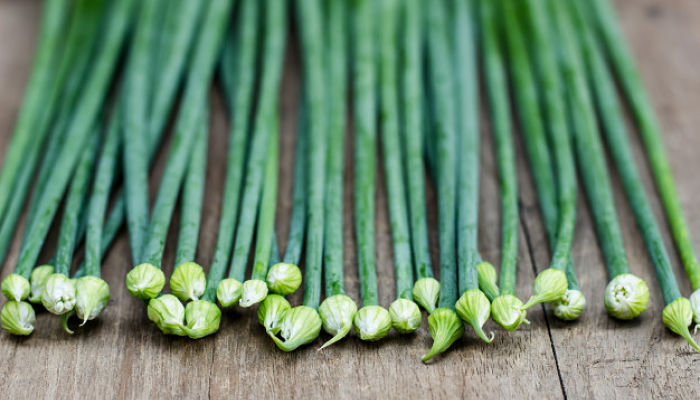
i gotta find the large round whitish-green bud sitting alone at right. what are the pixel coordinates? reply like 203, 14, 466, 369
604, 274, 649, 319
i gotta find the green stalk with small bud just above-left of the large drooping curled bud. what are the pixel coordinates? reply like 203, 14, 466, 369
399, 1, 440, 314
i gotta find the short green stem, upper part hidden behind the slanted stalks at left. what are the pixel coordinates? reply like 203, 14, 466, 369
175, 111, 209, 267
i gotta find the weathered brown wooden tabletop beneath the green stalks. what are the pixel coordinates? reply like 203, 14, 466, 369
0, 0, 700, 399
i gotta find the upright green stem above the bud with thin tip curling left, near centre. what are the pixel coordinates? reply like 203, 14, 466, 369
322, 1, 348, 298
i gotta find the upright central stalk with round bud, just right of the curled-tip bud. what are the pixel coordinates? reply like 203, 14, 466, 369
350, 0, 391, 341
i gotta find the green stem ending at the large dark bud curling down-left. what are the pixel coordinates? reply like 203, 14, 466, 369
426, 2, 457, 308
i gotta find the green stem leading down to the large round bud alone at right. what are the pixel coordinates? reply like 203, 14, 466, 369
544, 2, 629, 279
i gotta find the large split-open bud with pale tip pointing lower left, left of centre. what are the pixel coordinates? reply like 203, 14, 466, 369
267, 306, 321, 351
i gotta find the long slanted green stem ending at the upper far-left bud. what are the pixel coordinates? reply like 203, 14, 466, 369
11, 0, 133, 277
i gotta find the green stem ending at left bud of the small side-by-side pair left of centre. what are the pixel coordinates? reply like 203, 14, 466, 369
229, 0, 286, 282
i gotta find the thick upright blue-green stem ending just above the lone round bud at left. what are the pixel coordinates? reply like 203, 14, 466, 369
121, 0, 165, 263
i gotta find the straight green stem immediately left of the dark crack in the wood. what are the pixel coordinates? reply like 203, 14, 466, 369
480, 1, 518, 295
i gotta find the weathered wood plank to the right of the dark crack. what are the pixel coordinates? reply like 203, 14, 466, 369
520, 0, 700, 398
